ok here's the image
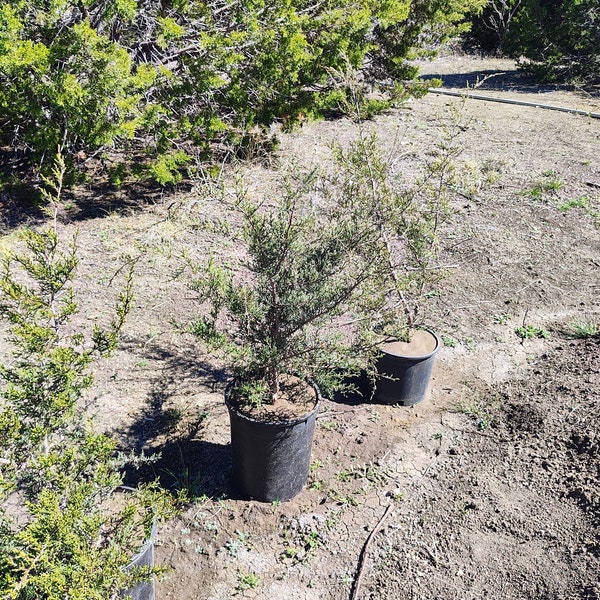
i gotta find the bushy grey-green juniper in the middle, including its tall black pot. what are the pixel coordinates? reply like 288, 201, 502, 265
191, 176, 365, 501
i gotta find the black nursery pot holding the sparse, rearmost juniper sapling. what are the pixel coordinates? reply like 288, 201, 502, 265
373, 329, 440, 406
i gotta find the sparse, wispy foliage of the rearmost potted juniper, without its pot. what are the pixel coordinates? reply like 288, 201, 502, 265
329, 114, 460, 341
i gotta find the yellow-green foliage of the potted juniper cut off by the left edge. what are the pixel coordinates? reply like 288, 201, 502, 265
0, 157, 178, 600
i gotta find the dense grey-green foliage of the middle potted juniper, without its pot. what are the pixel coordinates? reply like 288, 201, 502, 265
192, 170, 369, 404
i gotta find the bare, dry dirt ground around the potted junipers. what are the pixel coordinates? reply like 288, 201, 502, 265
0, 56, 600, 600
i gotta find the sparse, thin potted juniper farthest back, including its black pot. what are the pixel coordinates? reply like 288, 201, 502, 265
333, 129, 456, 406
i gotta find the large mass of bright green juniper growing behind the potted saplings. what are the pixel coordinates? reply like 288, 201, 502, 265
0, 0, 484, 184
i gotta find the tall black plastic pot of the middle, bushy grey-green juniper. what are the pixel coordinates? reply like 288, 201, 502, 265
225, 382, 321, 502
